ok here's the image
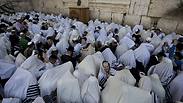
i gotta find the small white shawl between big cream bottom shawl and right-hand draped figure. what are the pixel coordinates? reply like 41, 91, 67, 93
138, 76, 152, 92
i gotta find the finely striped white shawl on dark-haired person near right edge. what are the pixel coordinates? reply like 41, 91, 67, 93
149, 57, 173, 85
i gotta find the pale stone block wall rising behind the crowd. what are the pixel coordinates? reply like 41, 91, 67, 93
2, 0, 183, 33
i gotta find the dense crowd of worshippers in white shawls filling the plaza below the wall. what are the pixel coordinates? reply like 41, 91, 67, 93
0, 12, 183, 103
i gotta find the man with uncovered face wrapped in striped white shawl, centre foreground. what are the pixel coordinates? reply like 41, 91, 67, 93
98, 61, 111, 90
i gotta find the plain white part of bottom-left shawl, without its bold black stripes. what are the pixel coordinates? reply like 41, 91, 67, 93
4, 68, 37, 100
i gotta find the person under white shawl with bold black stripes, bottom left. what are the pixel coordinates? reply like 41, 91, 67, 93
4, 68, 39, 103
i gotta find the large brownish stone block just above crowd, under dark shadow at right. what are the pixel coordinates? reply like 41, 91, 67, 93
157, 18, 178, 33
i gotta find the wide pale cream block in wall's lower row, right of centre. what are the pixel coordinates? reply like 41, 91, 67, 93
124, 15, 141, 26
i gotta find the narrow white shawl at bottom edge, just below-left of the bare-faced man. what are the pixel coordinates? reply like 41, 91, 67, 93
81, 76, 100, 103
